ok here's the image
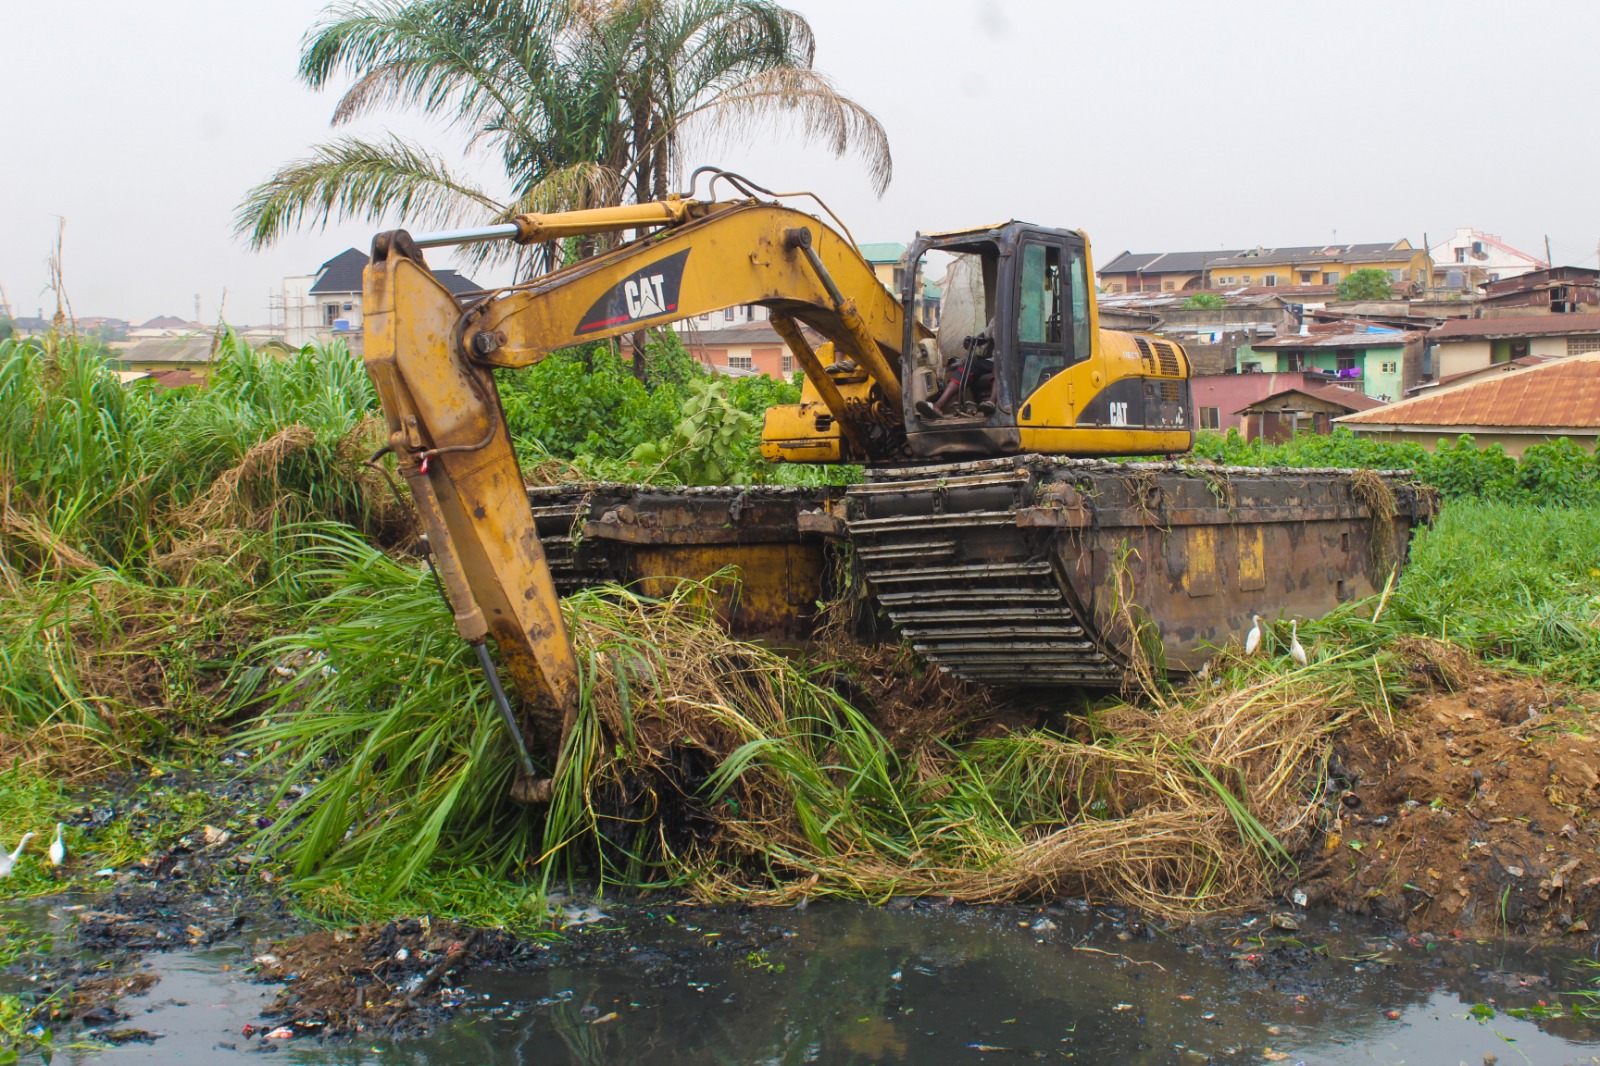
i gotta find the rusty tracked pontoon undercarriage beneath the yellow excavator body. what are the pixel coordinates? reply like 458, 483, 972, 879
530, 456, 1434, 687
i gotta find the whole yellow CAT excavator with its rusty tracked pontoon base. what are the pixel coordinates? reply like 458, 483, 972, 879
363, 168, 1430, 802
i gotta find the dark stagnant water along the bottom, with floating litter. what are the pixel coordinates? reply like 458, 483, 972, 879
50, 904, 1600, 1066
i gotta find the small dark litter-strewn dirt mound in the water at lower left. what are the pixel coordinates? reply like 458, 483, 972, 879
256, 919, 517, 1034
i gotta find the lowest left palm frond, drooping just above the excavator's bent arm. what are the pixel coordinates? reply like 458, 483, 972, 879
234, 136, 504, 248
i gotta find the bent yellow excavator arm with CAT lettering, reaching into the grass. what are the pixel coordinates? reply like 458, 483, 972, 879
363, 198, 904, 784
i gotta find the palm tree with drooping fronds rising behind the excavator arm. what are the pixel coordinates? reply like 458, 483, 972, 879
235, 0, 891, 271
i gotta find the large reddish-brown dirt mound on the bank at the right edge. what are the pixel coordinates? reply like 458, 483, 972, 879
1291, 664, 1600, 938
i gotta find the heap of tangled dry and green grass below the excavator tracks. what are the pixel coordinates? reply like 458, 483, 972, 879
552, 576, 1358, 917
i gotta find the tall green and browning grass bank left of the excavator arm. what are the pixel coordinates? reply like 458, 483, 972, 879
0, 333, 402, 745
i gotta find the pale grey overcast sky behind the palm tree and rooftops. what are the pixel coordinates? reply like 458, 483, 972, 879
0, 0, 1600, 323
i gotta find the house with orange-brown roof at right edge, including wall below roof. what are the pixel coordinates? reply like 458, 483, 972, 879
1338, 352, 1600, 456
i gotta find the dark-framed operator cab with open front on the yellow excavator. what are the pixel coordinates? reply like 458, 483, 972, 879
901, 222, 1093, 456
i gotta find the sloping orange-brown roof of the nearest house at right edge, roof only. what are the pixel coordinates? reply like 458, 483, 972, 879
1338, 352, 1600, 429
